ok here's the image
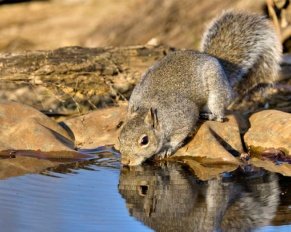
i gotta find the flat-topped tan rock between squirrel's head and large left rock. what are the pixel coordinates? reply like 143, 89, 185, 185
64, 106, 127, 149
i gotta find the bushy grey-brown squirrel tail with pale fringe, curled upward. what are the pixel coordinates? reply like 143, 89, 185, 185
201, 11, 282, 97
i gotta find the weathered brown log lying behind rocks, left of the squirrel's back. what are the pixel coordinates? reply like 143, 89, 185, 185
0, 46, 173, 112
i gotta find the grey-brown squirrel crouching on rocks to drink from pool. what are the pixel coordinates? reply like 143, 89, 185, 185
119, 10, 282, 166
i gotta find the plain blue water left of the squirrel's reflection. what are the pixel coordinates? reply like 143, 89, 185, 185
0, 167, 151, 232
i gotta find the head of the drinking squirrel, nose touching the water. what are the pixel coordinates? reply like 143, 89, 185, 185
119, 108, 160, 166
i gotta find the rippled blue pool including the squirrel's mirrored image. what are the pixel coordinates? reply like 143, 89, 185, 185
0, 162, 291, 232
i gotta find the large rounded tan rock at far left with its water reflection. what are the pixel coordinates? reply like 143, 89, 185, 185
0, 102, 104, 179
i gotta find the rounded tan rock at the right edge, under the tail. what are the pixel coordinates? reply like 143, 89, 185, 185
244, 110, 291, 155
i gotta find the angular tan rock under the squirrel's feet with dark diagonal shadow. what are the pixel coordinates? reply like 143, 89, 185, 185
174, 115, 243, 164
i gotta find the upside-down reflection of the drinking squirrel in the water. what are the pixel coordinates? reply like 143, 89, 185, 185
118, 163, 279, 231
